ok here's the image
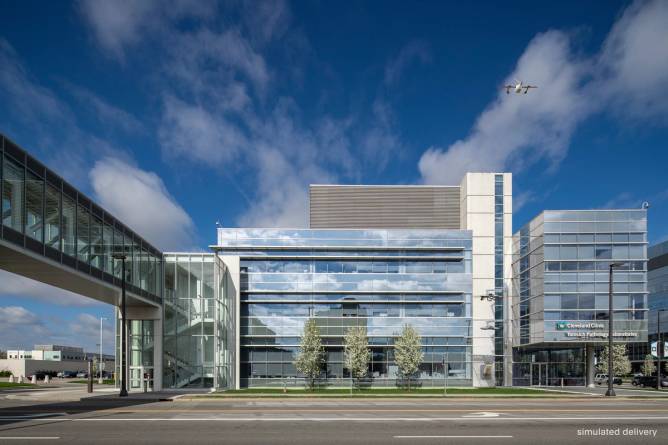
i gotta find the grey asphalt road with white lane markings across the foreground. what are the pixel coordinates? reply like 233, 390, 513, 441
0, 386, 668, 445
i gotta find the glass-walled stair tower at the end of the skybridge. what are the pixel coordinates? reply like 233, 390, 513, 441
163, 254, 235, 388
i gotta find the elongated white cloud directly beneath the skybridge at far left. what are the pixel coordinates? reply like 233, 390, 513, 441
0, 270, 102, 307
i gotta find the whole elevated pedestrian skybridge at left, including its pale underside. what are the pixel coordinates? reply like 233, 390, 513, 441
0, 134, 162, 307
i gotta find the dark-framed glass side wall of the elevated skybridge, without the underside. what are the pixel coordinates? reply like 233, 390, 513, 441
0, 135, 162, 303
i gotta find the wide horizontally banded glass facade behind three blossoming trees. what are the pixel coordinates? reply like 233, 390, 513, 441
216, 229, 471, 387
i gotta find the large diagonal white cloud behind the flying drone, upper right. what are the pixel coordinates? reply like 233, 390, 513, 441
418, 1, 668, 184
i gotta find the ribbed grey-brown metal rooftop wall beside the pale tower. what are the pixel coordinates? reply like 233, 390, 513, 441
309, 185, 460, 229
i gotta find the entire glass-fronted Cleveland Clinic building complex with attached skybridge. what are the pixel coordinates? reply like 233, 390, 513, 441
0, 135, 652, 390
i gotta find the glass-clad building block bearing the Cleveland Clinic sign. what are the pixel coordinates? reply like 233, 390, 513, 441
513, 210, 647, 385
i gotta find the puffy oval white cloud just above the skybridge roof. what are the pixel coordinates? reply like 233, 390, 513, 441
90, 158, 194, 250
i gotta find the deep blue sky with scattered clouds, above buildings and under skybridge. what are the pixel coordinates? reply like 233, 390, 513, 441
0, 0, 668, 354
